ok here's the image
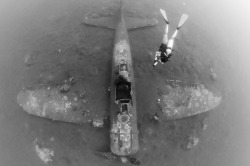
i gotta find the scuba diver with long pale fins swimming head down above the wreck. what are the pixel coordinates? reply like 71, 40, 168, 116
153, 9, 188, 67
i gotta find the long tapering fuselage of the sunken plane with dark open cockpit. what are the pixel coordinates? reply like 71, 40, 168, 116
110, 15, 139, 156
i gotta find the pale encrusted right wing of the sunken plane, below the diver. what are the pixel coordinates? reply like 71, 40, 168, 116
158, 80, 221, 120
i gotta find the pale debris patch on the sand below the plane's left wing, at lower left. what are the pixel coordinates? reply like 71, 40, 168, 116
34, 139, 54, 164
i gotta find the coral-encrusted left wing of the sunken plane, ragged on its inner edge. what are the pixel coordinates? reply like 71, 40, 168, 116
17, 85, 105, 127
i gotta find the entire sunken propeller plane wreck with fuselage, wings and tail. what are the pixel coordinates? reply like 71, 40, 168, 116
17, 1, 221, 156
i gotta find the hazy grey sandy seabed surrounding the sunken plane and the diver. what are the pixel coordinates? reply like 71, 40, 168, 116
0, 0, 250, 166
